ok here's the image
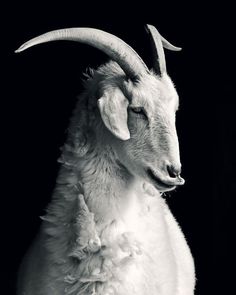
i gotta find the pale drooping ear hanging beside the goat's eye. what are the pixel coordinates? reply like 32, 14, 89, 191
98, 88, 130, 140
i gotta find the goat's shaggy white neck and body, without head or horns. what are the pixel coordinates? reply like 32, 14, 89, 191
15, 26, 195, 295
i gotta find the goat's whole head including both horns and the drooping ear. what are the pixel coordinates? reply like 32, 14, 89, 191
16, 25, 184, 191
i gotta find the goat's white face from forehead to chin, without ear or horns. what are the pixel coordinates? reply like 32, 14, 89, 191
125, 74, 184, 191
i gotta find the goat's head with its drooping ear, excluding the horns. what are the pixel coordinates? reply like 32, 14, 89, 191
98, 70, 184, 192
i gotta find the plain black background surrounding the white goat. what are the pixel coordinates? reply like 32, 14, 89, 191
1, 1, 236, 295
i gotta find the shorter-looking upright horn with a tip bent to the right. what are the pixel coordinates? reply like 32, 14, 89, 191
146, 25, 182, 75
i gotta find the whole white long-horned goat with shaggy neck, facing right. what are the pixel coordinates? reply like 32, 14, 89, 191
16, 25, 195, 295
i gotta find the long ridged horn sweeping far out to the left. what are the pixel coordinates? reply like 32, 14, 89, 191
15, 28, 149, 79
